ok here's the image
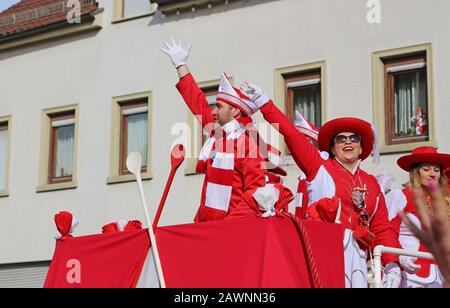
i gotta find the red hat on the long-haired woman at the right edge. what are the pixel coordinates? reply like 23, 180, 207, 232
397, 146, 450, 172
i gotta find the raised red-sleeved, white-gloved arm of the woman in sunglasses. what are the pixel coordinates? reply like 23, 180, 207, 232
241, 83, 323, 181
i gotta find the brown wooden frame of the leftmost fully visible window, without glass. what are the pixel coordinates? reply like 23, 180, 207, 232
47, 111, 76, 185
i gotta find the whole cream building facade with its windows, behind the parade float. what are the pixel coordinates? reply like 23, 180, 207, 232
0, 0, 450, 285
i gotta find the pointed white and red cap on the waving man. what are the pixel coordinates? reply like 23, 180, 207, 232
217, 73, 258, 117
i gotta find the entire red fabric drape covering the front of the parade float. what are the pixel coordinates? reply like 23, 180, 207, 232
45, 216, 344, 288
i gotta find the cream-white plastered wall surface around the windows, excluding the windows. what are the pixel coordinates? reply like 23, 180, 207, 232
0, 0, 450, 263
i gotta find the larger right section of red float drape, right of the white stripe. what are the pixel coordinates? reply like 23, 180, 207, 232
157, 217, 344, 288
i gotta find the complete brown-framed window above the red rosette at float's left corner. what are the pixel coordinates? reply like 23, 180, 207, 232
48, 112, 75, 184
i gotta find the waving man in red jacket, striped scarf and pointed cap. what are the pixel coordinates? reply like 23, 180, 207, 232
162, 39, 280, 222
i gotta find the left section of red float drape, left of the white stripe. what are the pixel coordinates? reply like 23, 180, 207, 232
44, 230, 150, 288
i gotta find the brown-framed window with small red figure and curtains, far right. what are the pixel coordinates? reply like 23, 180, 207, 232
385, 55, 429, 144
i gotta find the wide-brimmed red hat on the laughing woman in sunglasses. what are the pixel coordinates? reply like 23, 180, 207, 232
319, 118, 375, 160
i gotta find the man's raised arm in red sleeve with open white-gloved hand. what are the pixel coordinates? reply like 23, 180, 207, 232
161, 38, 214, 128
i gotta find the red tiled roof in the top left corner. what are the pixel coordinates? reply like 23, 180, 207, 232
0, 0, 98, 38
